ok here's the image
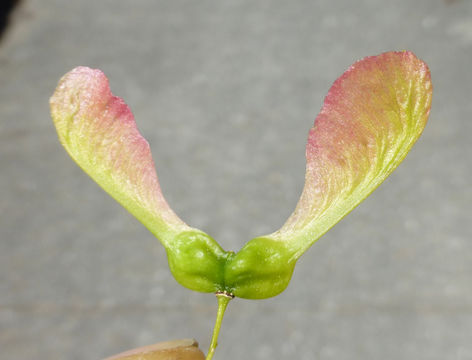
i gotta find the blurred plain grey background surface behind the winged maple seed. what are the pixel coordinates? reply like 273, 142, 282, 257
0, 0, 472, 360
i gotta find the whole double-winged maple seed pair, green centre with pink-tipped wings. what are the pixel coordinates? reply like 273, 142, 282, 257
50, 51, 432, 299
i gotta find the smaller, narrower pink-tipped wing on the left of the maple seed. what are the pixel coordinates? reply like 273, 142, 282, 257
50, 67, 191, 245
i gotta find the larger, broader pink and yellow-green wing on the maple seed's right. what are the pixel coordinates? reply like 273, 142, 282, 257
264, 51, 432, 258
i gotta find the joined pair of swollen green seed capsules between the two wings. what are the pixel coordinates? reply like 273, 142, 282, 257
167, 231, 296, 299
